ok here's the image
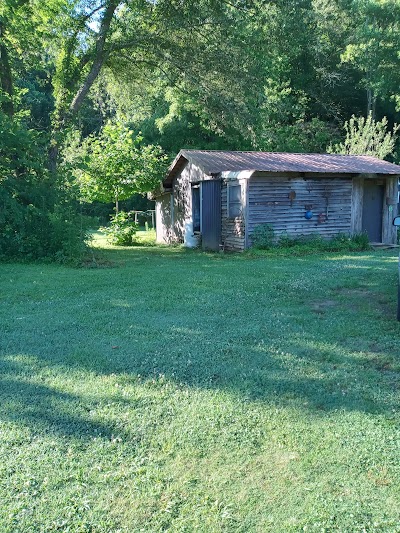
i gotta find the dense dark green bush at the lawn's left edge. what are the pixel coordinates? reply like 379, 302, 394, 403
0, 112, 87, 262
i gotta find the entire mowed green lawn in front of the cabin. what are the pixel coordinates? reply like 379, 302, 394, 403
0, 234, 400, 533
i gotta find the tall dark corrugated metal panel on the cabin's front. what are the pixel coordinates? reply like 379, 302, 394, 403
201, 180, 221, 251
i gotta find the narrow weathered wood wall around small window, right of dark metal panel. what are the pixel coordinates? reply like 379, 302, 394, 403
221, 180, 246, 251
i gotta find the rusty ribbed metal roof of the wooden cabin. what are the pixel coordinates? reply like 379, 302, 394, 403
165, 150, 400, 181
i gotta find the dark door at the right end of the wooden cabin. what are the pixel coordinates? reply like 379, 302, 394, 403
362, 179, 385, 242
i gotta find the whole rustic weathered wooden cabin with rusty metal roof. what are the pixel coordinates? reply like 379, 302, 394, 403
156, 150, 400, 250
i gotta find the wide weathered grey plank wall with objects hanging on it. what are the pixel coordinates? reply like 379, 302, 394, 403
247, 173, 352, 245
